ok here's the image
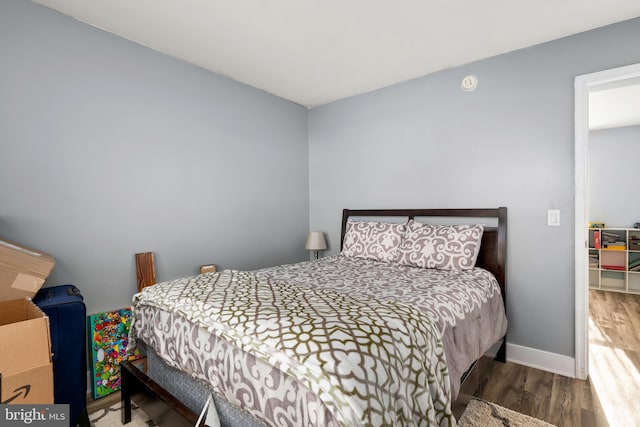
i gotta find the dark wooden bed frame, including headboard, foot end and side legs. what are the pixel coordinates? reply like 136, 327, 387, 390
121, 207, 507, 426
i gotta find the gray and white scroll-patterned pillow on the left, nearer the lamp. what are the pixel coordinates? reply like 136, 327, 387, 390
342, 221, 406, 262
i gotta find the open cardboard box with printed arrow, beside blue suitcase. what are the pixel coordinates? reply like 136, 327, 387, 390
0, 298, 53, 405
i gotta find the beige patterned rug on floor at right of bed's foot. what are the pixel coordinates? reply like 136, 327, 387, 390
458, 399, 553, 427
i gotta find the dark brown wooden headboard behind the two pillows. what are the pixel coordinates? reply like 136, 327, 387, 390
340, 207, 507, 304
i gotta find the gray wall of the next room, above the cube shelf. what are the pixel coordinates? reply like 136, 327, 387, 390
589, 126, 640, 228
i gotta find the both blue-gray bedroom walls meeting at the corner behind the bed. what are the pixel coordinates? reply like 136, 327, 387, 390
0, 0, 640, 362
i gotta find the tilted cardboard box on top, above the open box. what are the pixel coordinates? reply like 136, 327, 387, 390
0, 239, 55, 301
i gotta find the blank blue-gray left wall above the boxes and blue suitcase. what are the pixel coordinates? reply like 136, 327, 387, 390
0, 0, 309, 312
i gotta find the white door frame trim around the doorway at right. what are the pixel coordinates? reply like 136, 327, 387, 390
574, 64, 640, 380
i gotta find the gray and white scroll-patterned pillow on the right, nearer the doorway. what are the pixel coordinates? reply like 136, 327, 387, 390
399, 220, 484, 270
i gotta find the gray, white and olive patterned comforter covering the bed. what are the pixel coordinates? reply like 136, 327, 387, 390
131, 256, 506, 426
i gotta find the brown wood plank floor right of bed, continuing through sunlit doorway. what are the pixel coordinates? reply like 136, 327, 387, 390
454, 290, 640, 427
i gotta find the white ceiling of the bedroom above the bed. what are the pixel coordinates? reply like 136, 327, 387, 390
32, 0, 640, 107
